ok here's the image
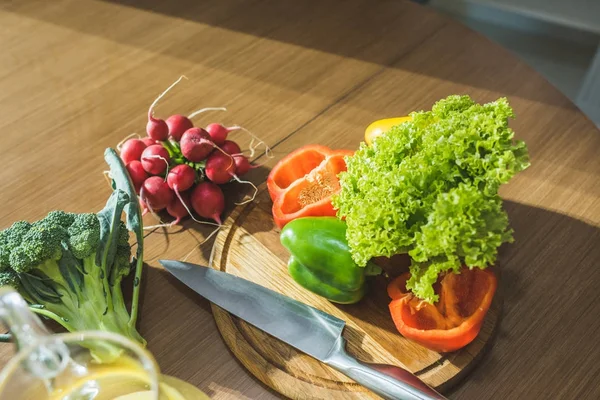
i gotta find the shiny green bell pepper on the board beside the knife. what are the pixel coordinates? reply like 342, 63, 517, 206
280, 217, 381, 304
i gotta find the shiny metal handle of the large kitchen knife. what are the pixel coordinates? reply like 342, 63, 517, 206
324, 336, 447, 400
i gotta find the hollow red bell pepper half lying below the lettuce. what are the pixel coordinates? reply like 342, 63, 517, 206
388, 267, 498, 352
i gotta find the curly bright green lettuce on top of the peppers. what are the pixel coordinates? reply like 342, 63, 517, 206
333, 95, 529, 303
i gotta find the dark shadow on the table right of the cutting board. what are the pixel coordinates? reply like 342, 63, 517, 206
448, 201, 600, 398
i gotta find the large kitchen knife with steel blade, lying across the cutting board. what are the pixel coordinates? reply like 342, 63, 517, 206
159, 260, 445, 400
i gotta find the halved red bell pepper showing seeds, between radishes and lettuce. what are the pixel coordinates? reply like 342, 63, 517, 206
267, 144, 354, 228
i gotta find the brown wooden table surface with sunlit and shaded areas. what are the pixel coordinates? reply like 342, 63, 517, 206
0, 0, 600, 399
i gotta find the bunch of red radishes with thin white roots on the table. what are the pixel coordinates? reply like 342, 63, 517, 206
119, 78, 262, 225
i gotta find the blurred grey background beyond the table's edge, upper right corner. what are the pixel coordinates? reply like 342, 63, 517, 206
429, 0, 600, 127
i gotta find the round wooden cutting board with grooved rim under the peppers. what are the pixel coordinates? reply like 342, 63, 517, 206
212, 185, 500, 399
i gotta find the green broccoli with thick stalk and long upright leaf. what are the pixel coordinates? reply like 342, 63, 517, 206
0, 149, 146, 361
